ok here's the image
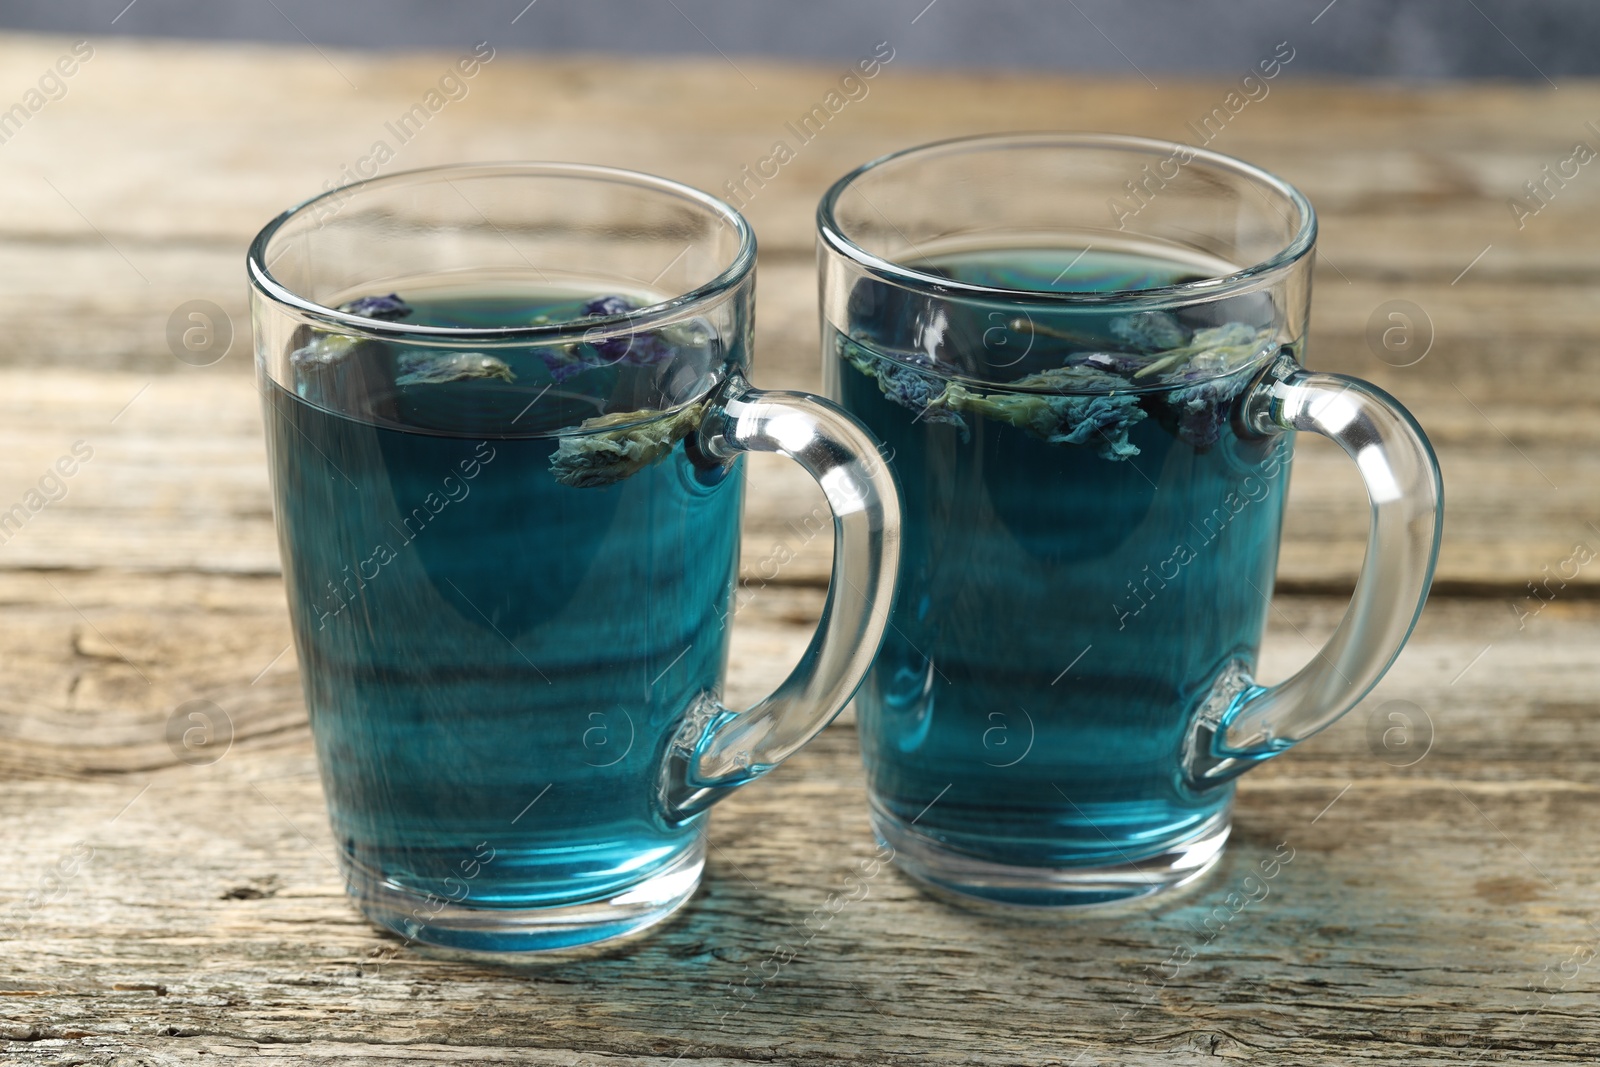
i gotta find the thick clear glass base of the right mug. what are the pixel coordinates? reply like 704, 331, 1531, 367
872, 803, 1232, 910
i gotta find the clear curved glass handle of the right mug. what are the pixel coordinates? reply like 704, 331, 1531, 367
1184, 352, 1443, 790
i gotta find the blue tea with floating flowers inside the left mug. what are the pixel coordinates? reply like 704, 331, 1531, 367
264, 286, 742, 949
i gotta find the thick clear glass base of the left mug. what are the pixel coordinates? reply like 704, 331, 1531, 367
344, 835, 706, 955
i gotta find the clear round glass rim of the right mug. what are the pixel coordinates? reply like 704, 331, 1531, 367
816, 131, 1317, 306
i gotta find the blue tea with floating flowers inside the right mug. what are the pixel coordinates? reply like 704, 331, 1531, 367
829, 250, 1291, 904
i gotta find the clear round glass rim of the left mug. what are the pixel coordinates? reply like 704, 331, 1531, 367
245, 162, 755, 346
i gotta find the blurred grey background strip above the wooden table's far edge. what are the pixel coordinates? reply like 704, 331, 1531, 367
0, 0, 1600, 85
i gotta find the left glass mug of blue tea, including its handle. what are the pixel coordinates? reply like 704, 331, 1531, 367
248, 163, 899, 952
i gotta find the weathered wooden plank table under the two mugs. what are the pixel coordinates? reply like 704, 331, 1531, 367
0, 27, 1600, 1067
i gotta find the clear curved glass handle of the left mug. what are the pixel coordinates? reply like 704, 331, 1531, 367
661, 373, 901, 822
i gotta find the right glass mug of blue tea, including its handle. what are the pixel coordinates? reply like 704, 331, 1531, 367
818, 134, 1442, 907
